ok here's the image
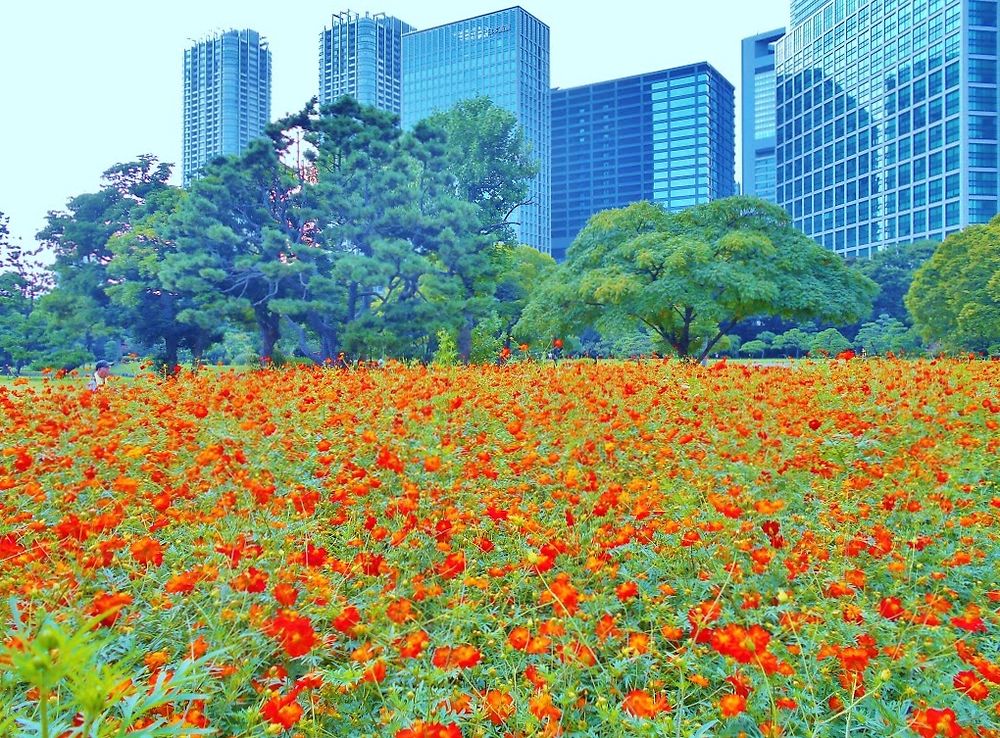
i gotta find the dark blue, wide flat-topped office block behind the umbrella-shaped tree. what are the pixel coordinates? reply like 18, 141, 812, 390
552, 63, 736, 259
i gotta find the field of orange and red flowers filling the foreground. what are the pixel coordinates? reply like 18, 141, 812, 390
0, 360, 1000, 738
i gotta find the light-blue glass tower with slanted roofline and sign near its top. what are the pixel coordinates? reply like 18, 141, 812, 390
402, 7, 551, 253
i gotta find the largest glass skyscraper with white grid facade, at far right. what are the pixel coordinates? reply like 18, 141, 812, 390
775, 0, 1000, 257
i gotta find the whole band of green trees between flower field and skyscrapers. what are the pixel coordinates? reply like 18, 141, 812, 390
0, 98, 1000, 372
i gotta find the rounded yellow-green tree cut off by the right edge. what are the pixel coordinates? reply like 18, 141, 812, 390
906, 216, 1000, 353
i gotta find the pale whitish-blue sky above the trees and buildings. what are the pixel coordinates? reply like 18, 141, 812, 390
0, 0, 789, 250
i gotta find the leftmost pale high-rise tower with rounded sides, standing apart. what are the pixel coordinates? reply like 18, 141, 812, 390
182, 28, 271, 187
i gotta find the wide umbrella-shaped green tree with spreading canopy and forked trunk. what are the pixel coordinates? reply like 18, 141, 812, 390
522, 197, 877, 360
